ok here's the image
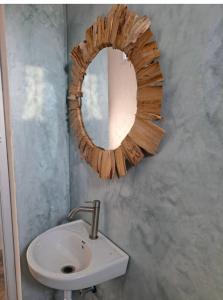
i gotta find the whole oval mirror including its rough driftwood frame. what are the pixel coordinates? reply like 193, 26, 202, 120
68, 4, 164, 179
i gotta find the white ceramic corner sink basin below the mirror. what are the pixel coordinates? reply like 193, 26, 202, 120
27, 220, 129, 290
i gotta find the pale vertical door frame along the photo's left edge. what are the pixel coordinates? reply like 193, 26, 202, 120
0, 5, 22, 300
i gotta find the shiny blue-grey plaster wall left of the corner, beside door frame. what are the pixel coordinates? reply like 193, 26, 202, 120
6, 5, 70, 300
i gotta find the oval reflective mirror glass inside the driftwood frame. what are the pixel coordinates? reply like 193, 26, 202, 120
81, 47, 137, 150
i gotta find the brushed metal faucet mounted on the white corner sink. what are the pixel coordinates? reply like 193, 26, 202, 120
67, 200, 100, 240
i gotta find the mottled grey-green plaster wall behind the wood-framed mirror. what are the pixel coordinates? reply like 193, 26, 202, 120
68, 5, 223, 300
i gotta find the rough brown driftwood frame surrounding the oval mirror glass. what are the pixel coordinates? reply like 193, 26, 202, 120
68, 4, 164, 179
